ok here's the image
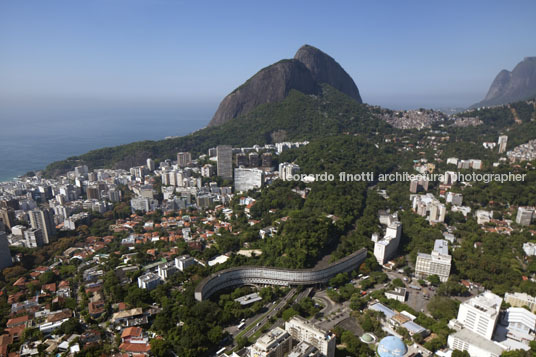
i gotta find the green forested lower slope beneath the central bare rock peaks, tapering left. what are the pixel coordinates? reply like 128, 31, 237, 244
44, 84, 386, 176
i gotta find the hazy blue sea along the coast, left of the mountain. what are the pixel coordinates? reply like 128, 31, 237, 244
0, 98, 215, 182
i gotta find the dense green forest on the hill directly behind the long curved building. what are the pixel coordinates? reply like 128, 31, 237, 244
243, 135, 400, 268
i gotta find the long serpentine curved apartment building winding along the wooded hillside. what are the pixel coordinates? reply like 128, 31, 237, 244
195, 248, 367, 301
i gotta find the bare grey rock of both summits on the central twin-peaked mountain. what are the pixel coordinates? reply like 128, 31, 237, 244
209, 45, 362, 127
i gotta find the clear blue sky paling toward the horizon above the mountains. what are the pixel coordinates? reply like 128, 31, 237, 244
0, 0, 536, 108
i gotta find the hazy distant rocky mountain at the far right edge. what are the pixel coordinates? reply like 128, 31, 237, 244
470, 57, 536, 108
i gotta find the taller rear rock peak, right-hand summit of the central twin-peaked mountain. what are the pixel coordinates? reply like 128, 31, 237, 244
294, 45, 362, 103
